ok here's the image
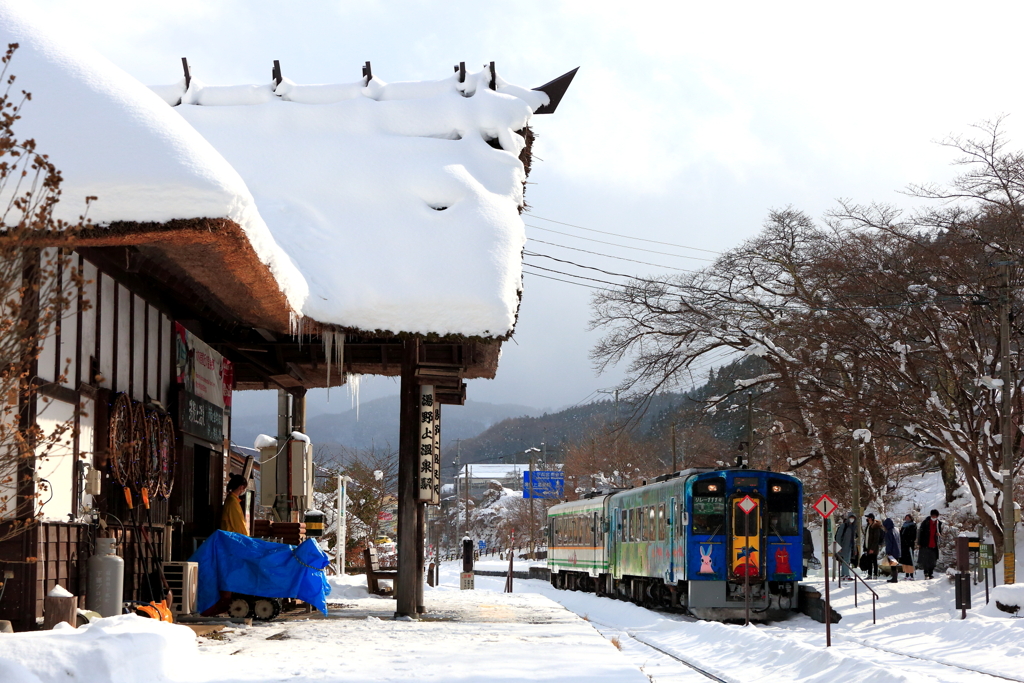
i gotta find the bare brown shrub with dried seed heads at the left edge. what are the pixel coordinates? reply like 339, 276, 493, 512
0, 43, 95, 541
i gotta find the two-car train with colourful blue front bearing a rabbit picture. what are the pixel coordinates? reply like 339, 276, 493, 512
547, 468, 804, 621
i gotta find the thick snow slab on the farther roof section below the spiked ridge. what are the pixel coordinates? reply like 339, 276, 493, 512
154, 68, 548, 337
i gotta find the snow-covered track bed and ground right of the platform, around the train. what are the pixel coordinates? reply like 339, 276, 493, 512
468, 574, 1024, 682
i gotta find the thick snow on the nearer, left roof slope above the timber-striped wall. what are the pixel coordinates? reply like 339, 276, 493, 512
0, 0, 307, 308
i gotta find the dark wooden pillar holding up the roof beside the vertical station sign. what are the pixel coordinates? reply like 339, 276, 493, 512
394, 337, 423, 618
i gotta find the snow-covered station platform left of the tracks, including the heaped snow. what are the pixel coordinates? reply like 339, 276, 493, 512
0, 584, 649, 683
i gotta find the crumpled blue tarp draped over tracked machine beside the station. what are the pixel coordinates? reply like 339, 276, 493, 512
188, 531, 331, 614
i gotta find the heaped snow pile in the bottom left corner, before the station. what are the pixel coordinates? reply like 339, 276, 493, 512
0, 614, 199, 683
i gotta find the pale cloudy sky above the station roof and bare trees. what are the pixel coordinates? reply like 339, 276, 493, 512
34, 0, 1024, 412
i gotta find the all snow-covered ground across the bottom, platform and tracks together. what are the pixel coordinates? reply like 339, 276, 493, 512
0, 562, 1024, 683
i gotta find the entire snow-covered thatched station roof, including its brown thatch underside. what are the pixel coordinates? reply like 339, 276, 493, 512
0, 0, 564, 339
